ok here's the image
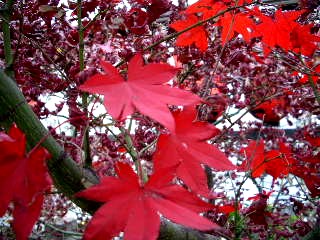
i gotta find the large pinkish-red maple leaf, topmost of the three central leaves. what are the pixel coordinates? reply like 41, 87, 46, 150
80, 54, 200, 130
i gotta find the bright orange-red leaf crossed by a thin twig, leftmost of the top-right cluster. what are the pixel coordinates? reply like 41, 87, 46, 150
170, 15, 208, 52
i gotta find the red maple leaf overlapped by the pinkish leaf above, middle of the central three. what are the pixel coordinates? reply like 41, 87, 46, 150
154, 108, 236, 196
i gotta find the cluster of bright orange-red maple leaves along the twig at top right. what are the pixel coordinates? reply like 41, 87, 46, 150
170, 0, 320, 56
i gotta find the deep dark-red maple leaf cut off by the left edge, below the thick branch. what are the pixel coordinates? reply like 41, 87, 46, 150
0, 126, 51, 239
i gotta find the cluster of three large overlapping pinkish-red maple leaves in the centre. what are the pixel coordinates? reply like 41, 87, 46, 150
77, 54, 236, 239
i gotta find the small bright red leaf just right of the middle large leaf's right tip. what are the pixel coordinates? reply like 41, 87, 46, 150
240, 140, 266, 178
